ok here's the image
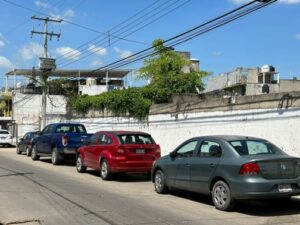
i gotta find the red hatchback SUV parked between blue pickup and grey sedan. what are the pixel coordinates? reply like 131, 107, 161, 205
76, 131, 160, 180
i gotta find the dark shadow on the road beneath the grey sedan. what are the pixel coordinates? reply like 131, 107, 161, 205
170, 190, 300, 217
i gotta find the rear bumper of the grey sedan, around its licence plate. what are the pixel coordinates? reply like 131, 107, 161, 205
230, 178, 300, 199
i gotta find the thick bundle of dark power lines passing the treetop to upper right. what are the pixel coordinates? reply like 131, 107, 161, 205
94, 0, 277, 71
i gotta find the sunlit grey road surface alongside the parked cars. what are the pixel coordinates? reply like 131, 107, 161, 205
0, 148, 300, 225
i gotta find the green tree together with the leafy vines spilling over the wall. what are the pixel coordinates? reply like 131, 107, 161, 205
70, 39, 209, 120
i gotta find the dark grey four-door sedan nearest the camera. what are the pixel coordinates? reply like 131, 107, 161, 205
152, 136, 300, 210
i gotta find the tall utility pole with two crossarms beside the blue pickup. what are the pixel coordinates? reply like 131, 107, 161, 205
31, 16, 62, 130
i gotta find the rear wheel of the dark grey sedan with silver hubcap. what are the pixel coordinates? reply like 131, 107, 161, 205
212, 180, 235, 211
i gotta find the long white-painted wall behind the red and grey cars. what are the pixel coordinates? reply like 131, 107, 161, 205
69, 108, 300, 156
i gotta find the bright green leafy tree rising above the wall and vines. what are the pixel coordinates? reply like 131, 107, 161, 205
138, 39, 210, 93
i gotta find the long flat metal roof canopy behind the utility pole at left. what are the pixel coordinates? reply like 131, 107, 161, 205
6, 69, 131, 78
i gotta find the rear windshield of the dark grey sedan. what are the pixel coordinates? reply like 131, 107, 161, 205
229, 140, 285, 155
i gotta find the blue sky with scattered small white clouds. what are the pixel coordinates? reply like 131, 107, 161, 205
0, 0, 300, 87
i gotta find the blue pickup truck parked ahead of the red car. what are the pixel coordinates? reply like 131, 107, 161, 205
31, 123, 91, 165
